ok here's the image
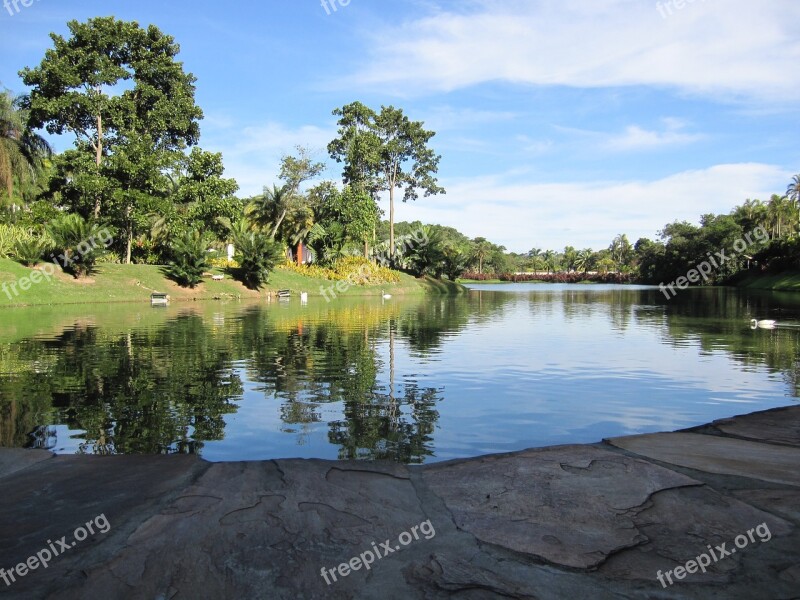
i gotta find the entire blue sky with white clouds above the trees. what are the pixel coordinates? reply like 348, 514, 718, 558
0, 0, 800, 252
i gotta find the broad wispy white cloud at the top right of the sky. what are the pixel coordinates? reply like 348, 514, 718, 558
347, 0, 800, 103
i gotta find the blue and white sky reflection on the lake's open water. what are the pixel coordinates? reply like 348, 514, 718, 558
376, 296, 793, 460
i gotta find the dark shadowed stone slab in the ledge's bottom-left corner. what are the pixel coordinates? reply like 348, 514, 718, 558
0, 450, 208, 598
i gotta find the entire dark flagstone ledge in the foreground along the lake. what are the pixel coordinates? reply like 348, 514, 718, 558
0, 407, 800, 600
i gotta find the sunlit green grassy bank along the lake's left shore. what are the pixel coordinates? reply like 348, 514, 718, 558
0, 259, 464, 306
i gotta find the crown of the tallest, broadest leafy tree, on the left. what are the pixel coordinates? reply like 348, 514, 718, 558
20, 17, 203, 224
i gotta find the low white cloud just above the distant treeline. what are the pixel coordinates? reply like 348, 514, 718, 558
384, 163, 791, 252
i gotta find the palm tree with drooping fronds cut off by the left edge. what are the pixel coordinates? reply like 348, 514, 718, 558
0, 91, 53, 200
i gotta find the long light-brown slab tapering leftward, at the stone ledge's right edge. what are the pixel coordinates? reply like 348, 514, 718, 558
608, 433, 800, 485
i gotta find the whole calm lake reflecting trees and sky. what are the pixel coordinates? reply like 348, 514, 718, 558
0, 284, 800, 463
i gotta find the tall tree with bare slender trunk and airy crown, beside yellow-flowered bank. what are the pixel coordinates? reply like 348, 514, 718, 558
328, 102, 445, 256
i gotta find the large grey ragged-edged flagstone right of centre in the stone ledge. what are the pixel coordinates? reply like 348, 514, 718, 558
425, 446, 700, 569
